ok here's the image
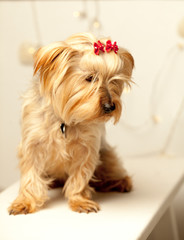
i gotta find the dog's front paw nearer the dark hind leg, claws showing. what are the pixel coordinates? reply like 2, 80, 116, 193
69, 199, 100, 213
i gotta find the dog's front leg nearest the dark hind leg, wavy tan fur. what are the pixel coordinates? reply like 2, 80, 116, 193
63, 148, 100, 213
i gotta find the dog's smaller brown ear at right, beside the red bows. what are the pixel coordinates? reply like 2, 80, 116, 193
118, 48, 134, 77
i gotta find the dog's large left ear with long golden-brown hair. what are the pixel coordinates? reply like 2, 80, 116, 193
34, 42, 76, 93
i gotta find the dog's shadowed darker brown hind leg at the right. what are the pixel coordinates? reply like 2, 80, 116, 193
90, 146, 132, 192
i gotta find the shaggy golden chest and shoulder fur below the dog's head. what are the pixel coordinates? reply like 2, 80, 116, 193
19, 81, 105, 178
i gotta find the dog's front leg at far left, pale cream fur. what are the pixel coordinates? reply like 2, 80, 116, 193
8, 143, 50, 215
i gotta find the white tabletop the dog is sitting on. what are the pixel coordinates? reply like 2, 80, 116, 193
0, 157, 184, 240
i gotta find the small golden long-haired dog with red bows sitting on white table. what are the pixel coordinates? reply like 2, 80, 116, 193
8, 33, 134, 215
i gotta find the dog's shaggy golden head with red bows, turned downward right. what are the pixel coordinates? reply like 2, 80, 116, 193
35, 33, 134, 125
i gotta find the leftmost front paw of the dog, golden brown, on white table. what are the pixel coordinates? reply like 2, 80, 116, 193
8, 201, 36, 215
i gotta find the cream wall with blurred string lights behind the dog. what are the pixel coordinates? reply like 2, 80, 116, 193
0, 0, 184, 239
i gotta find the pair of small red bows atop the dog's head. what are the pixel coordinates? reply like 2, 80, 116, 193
94, 40, 119, 55
